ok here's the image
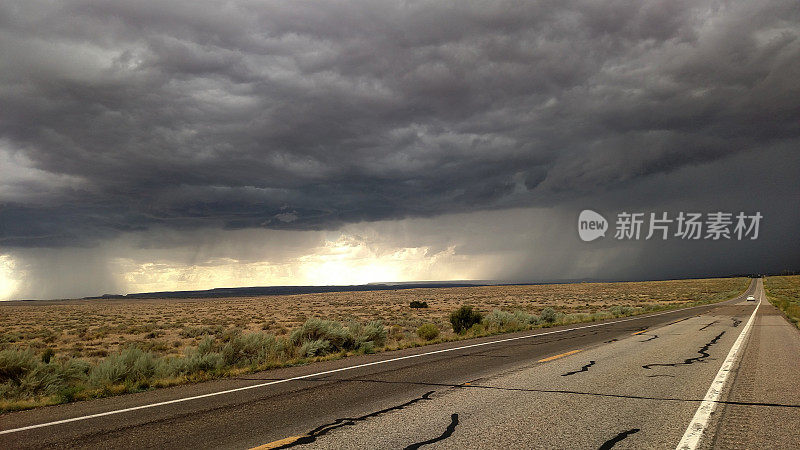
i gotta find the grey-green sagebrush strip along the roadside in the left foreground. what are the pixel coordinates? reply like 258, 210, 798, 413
0, 319, 388, 409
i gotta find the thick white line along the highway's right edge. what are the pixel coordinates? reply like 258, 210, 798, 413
675, 282, 764, 450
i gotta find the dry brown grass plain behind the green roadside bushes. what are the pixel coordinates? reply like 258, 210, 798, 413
0, 278, 749, 361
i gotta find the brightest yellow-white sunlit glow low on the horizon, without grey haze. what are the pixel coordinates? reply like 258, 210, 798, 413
0, 232, 481, 300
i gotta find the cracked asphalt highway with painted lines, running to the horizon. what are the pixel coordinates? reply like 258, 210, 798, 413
0, 280, 800, 449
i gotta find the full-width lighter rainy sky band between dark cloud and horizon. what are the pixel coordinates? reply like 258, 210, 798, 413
6, 142, 800, 299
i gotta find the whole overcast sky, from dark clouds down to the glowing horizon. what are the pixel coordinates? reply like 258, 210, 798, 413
0, 0, 800, 298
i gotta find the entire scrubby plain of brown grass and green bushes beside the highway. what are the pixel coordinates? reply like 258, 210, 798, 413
0, 278, 752, 411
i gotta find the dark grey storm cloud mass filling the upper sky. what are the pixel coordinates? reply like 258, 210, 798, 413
0, 0, 800, 247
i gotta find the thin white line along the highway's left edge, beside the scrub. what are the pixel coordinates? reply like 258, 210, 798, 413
0, 289, 760, 434
